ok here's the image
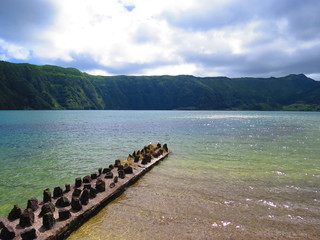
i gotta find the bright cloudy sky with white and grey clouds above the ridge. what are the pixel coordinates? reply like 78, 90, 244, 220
0, 0, 320, 80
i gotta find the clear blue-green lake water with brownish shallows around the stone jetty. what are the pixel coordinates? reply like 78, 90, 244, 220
0, 111, 320, 240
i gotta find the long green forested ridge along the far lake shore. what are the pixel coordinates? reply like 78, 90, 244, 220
0, 61, 320, 111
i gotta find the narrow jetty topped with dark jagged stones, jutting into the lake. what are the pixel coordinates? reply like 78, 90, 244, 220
0, 144, 170, 240
